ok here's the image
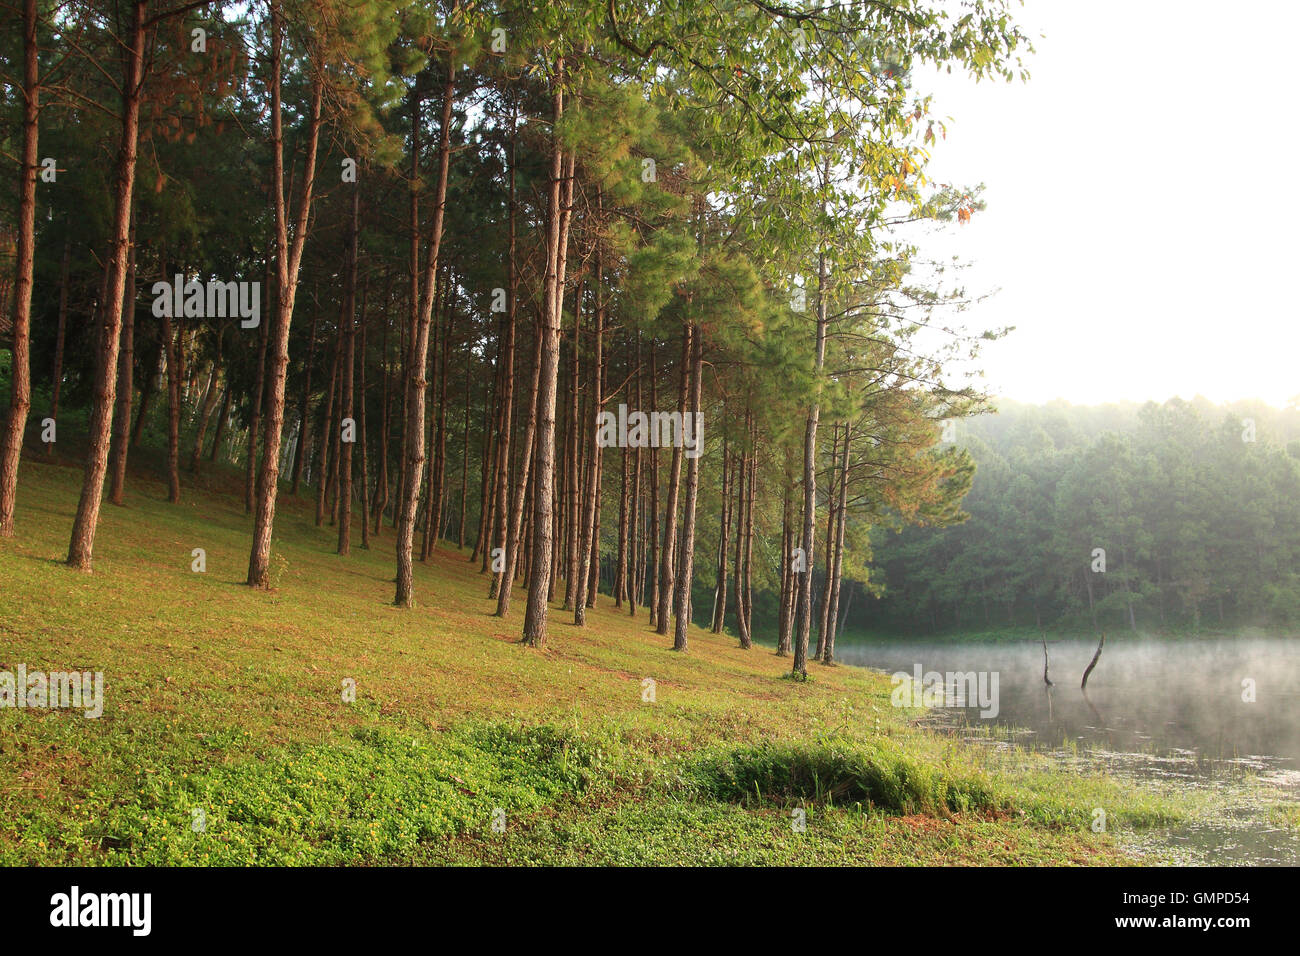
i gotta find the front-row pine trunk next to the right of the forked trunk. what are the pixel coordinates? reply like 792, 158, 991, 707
393, 67, 456, 607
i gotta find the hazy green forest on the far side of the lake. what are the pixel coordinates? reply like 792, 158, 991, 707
863, 398, 1300, 635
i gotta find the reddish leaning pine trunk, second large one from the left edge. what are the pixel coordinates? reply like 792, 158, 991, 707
66, 0, 148, 571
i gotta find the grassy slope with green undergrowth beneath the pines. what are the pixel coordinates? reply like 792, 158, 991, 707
0, 460, 1196, 865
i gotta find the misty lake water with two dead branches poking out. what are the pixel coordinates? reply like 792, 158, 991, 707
836, 636, 1300, 865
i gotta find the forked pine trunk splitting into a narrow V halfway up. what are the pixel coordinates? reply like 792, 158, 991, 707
248, 0, 324, 588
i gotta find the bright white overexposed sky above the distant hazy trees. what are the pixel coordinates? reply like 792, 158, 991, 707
914, 0, 1300, 406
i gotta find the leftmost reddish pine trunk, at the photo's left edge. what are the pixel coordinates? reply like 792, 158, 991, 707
0, 0, 39, 535
